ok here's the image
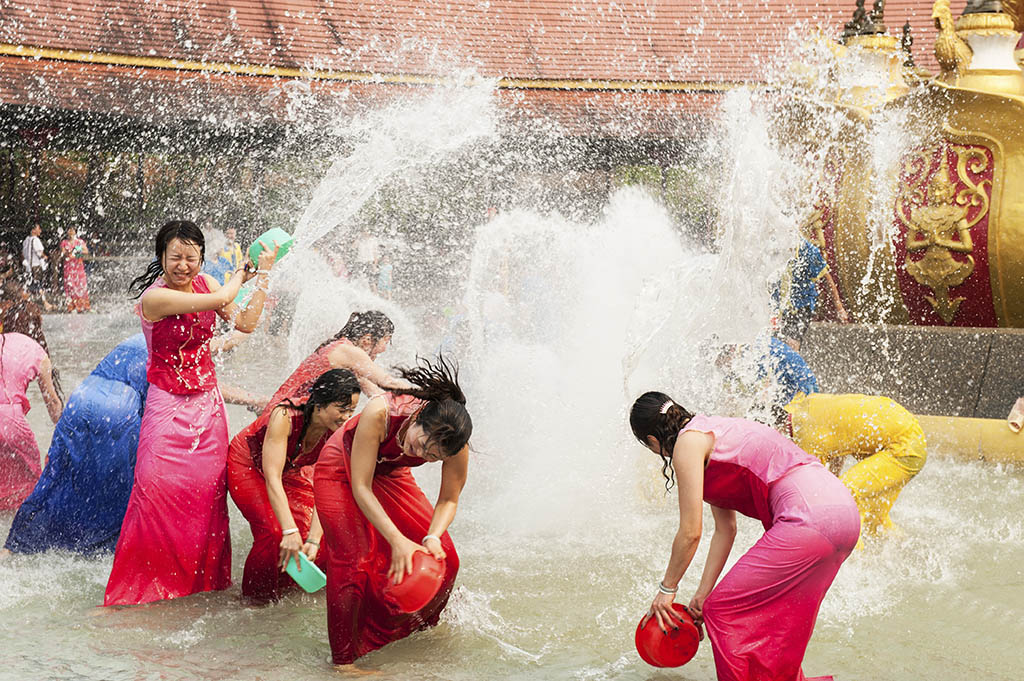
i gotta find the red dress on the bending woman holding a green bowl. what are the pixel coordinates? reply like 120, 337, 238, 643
227, 400, 330, 602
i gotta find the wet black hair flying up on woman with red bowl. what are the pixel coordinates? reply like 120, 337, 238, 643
391, 355, 473, 459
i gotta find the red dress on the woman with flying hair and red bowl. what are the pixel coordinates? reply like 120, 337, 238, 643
313, 392, 459, 665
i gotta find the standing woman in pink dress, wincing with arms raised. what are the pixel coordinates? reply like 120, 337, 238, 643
103, 220, 278, 605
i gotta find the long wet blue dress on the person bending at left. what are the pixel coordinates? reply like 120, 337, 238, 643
4, 334, 148, 553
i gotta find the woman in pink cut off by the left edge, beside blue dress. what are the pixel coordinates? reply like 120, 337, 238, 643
0, 333, 63, 511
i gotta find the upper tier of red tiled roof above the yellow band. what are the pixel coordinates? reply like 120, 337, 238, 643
0, 0, 966, 82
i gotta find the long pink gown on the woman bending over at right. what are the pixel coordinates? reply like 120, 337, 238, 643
682, 415, 860, 681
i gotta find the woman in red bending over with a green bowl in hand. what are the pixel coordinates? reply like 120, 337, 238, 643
227, 369, 359, 603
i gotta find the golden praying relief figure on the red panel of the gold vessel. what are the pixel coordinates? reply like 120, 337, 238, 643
906, 164, 974, 324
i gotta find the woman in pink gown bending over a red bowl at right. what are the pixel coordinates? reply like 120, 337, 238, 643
630, 392, 860, 681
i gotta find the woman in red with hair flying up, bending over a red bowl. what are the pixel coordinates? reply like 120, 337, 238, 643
313, 358, 473, 667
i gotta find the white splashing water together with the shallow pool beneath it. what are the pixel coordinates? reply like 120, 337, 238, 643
0, 35, 1024, 681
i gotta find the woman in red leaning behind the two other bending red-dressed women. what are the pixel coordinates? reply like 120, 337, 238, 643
264, 310, 409, 412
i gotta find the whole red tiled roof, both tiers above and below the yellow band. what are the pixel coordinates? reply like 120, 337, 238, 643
0, 0, 978, 135
